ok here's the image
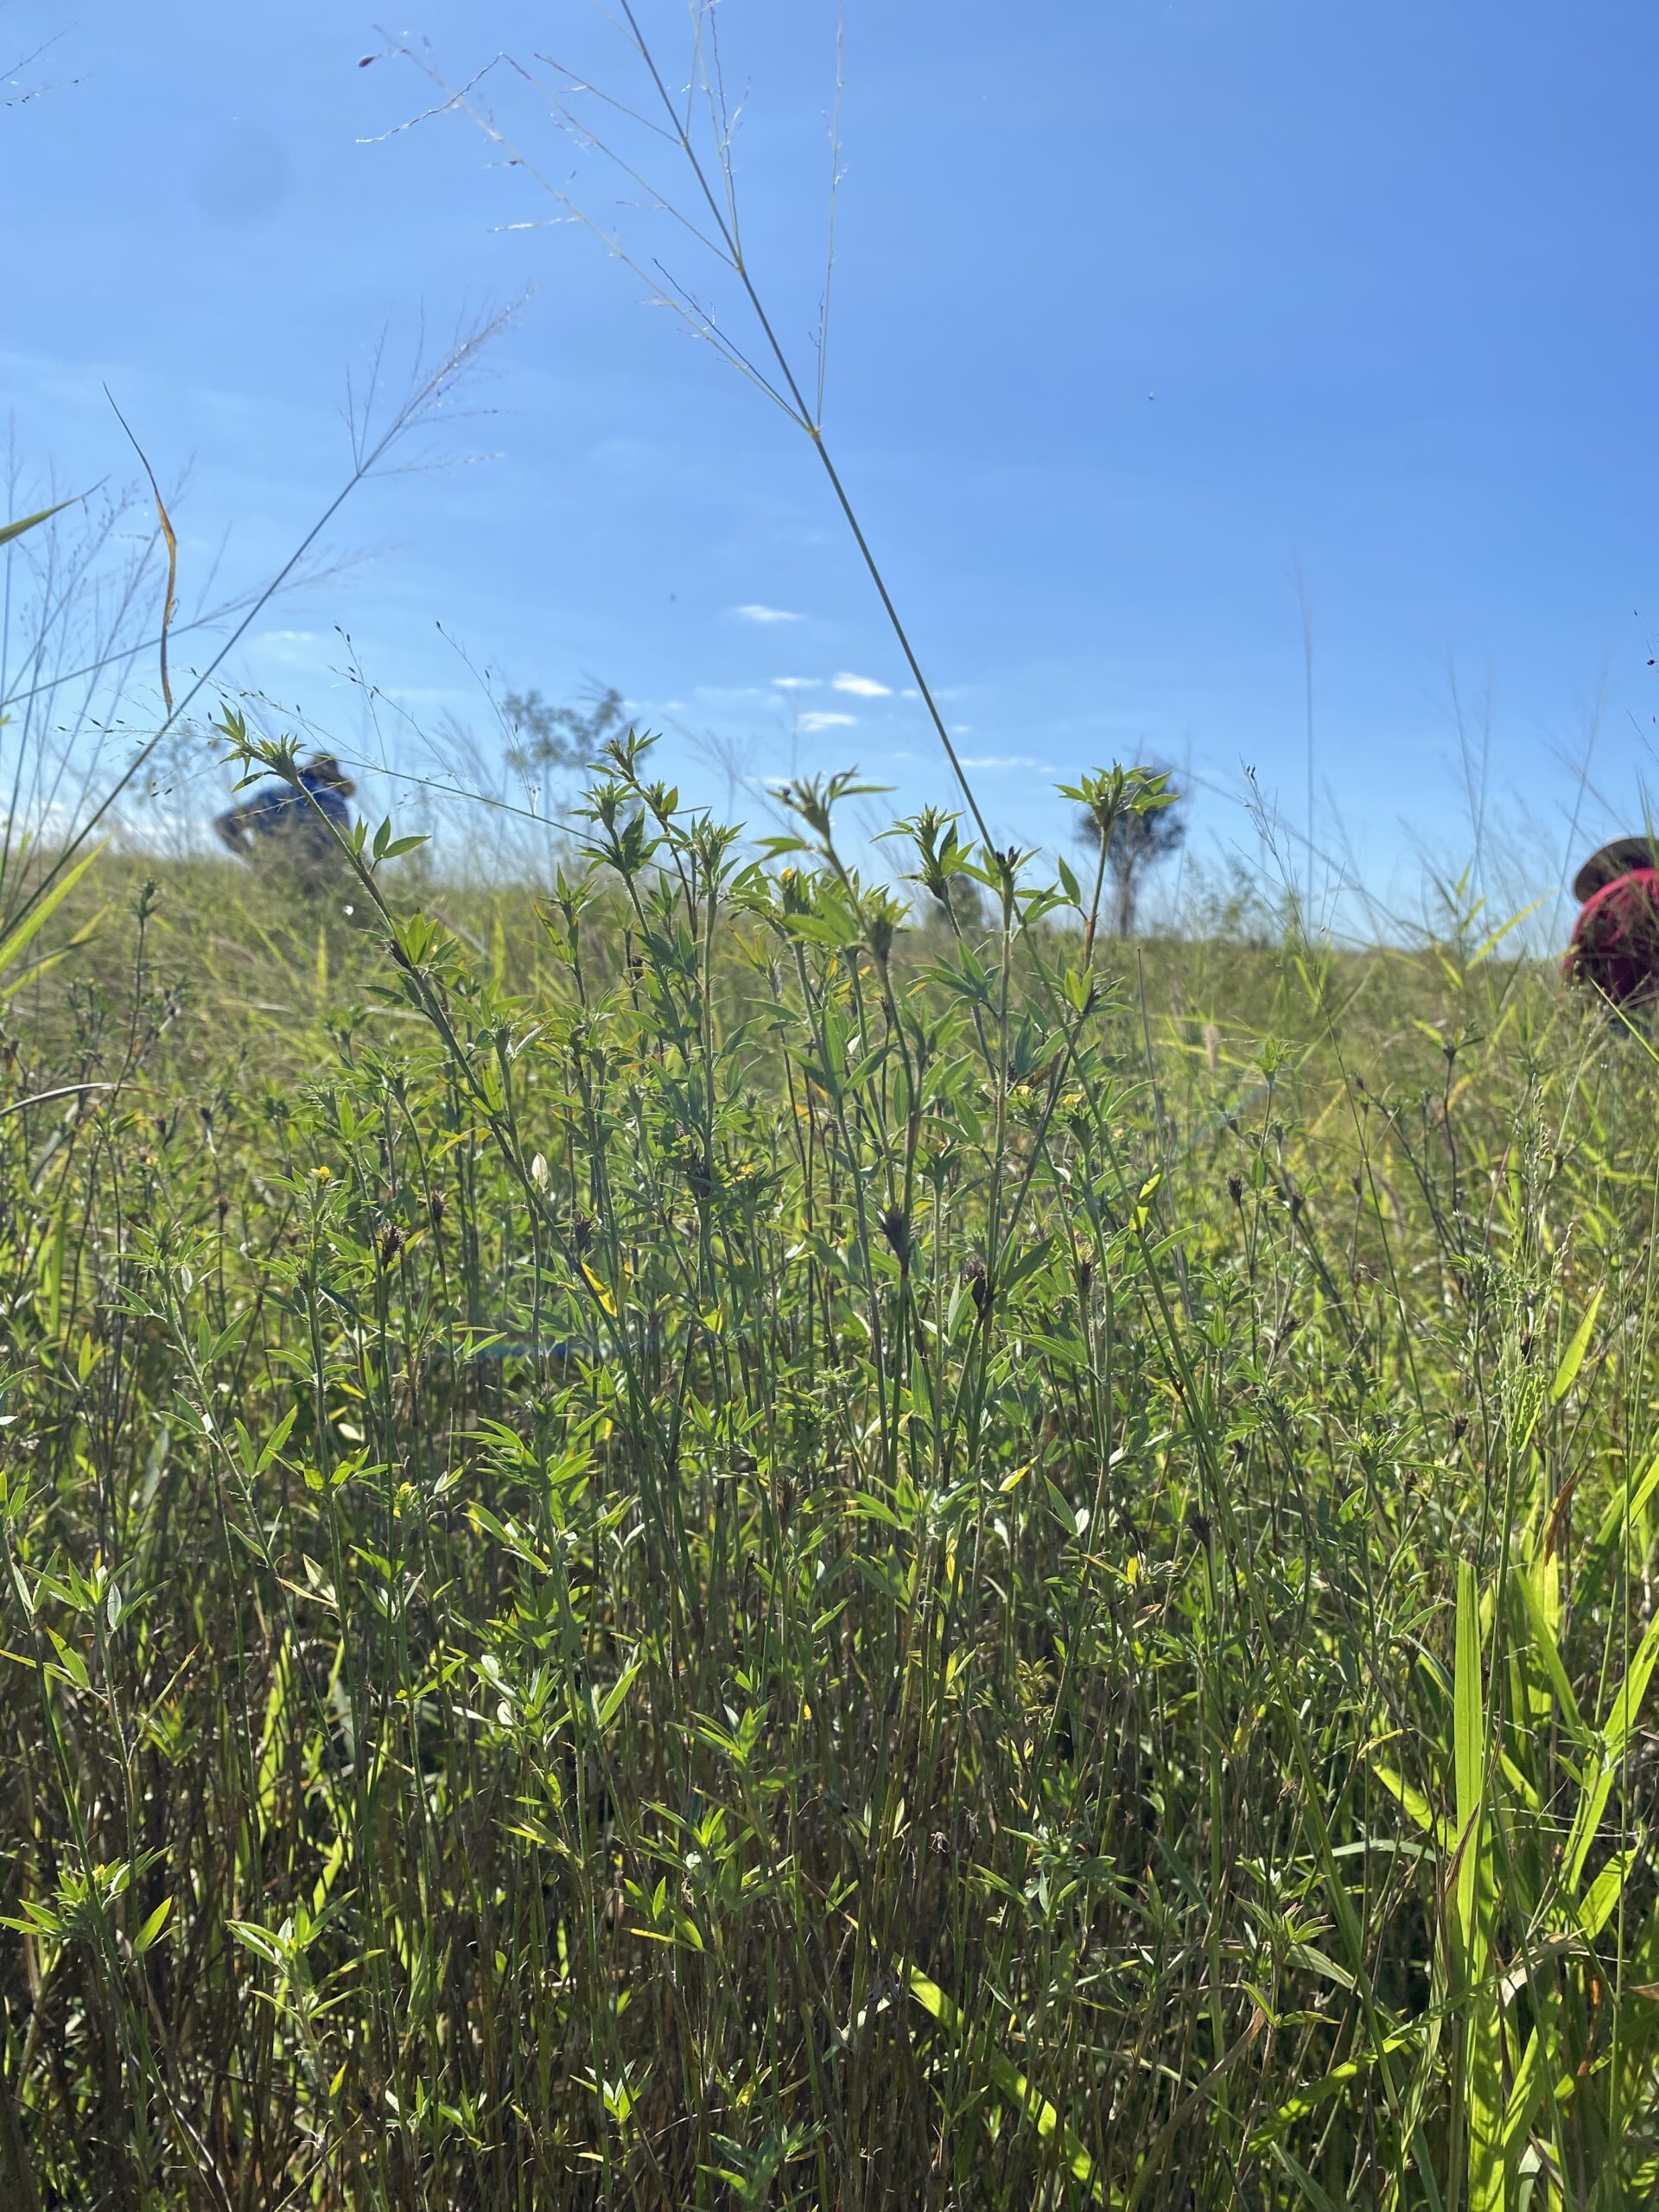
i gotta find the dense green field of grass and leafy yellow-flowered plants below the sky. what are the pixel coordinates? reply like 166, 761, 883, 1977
0, 746, 1659, 2212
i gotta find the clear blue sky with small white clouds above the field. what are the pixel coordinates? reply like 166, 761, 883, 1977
0, 0, 1659, 915
